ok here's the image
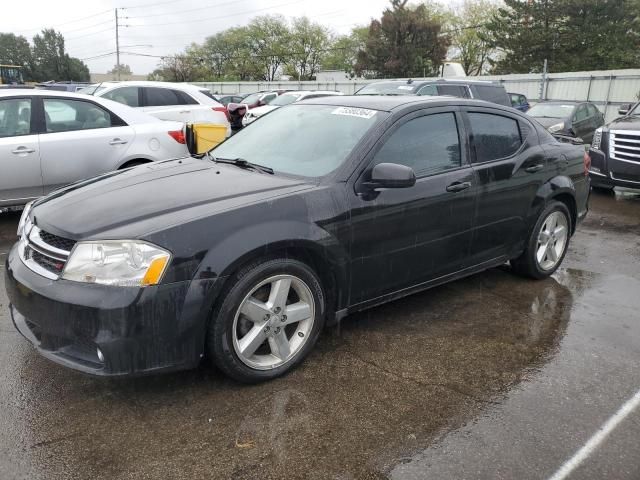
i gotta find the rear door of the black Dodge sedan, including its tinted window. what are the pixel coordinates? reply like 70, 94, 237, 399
464, 107, 548, 264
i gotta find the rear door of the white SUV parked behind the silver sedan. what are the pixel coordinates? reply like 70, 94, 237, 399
141, 87, 194, 123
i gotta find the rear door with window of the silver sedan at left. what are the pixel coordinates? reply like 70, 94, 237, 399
40, 97, 135, 193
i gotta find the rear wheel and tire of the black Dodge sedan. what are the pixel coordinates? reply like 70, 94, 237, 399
511, 201, 572, 279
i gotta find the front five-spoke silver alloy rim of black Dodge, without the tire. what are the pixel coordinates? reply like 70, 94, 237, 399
233, 275, 315, 370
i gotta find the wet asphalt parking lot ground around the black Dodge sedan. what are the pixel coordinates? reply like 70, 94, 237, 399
0, 188, 640, 480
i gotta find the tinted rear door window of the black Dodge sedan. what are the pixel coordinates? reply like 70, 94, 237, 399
467, 112, 522, 163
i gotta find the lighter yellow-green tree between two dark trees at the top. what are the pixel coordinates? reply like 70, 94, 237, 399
450, 0, 499, 75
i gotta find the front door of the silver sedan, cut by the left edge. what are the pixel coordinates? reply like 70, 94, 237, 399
0, 96, 42, 205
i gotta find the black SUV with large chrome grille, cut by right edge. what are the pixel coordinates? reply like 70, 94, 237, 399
589, 103, 640, 190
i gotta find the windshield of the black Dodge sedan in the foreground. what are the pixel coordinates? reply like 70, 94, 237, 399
211, 105, 386, 177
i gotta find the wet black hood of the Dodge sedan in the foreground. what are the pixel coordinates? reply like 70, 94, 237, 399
31, 158, 313, 240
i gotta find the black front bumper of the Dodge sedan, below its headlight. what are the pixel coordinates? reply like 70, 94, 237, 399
5, 246, 214, 376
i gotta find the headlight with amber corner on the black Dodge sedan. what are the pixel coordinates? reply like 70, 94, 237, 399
62, 241, 171, 287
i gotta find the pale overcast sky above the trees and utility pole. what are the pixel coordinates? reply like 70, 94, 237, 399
0, 0, 459, 74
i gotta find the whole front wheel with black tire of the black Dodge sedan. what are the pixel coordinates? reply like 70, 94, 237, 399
207, 258, 325, 383
